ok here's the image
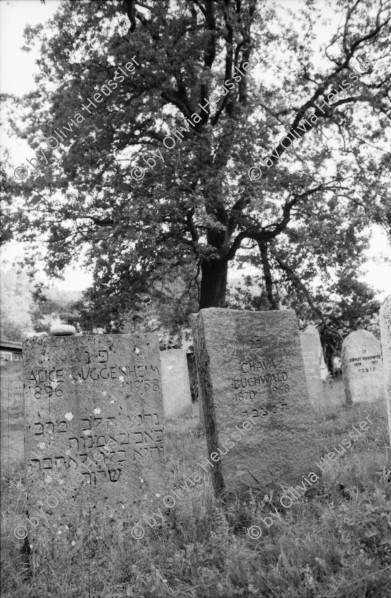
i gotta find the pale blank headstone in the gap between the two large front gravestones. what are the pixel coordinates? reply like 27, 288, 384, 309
160, 349, 192, 418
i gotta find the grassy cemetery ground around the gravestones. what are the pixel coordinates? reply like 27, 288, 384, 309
1, 381, 391, 598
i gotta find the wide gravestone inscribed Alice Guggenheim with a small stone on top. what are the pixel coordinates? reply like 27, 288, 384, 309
23, 334, 164, 542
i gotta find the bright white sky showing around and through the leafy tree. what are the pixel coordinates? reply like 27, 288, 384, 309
0, 0, 391, 300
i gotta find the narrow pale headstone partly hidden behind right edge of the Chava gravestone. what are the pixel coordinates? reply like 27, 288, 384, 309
300, 326, 326, 410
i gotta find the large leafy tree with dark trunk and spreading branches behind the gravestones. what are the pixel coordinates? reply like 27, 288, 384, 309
0, 0, 391, 336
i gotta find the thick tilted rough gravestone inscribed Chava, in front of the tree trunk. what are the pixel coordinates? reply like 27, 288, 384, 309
192, 308, 319, 496
